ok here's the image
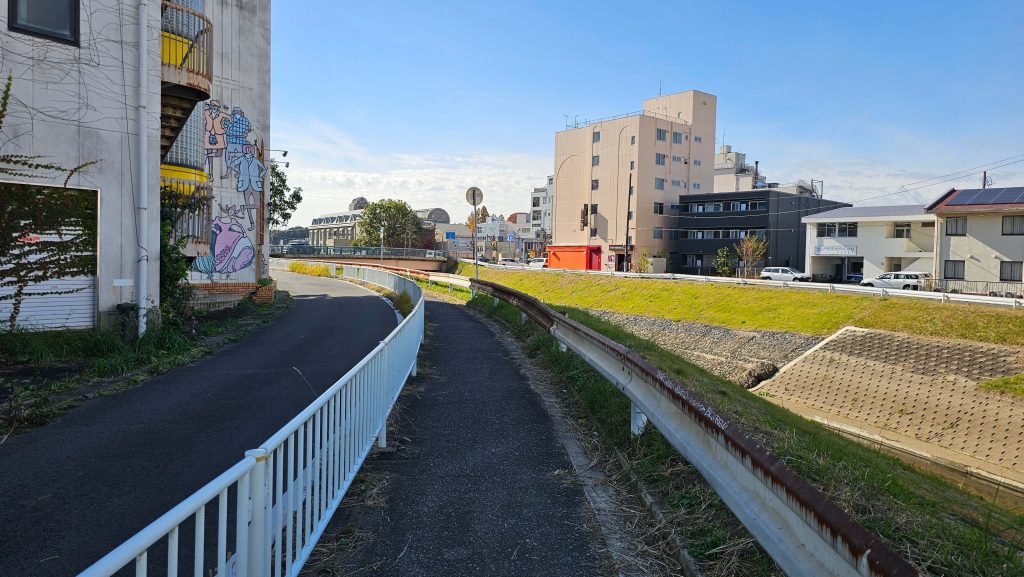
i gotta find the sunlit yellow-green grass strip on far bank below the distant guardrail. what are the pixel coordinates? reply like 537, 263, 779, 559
459, 263, 1024, 346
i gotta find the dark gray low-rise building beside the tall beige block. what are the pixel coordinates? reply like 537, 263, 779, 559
669, 189, 850, 274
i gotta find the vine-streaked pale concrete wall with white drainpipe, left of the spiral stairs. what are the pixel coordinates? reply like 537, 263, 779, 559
0, 0, 161, 324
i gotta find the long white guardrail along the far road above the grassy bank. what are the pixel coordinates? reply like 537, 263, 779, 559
459, 258, 1024, 308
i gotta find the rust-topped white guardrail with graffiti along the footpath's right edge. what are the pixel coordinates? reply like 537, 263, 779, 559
473, 281, 918, 577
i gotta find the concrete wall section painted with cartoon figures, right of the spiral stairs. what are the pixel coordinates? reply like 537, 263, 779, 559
189, 0, 270, 283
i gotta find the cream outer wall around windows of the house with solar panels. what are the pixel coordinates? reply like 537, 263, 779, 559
934, 211, 1024, 282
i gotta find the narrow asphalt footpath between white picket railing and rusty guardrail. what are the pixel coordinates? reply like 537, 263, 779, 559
321, 301, 608, 576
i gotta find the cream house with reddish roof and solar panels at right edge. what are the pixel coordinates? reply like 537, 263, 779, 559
928, 187, 1024, 295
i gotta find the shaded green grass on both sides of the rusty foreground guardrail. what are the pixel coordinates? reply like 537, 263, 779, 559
464, 293, 1024, 577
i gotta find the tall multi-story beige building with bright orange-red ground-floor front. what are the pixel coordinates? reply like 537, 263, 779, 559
548, 90, 717, 271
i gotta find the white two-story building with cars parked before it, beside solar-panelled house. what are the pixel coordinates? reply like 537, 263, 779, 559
803, 205, 935, 282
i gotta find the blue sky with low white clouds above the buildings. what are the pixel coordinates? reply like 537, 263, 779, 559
270, 0, 1024, 225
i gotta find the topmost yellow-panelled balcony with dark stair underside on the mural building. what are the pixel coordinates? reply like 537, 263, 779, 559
160, 0, 213, 158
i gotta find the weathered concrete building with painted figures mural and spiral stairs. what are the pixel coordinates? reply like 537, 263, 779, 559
0, 0, 270, 328
